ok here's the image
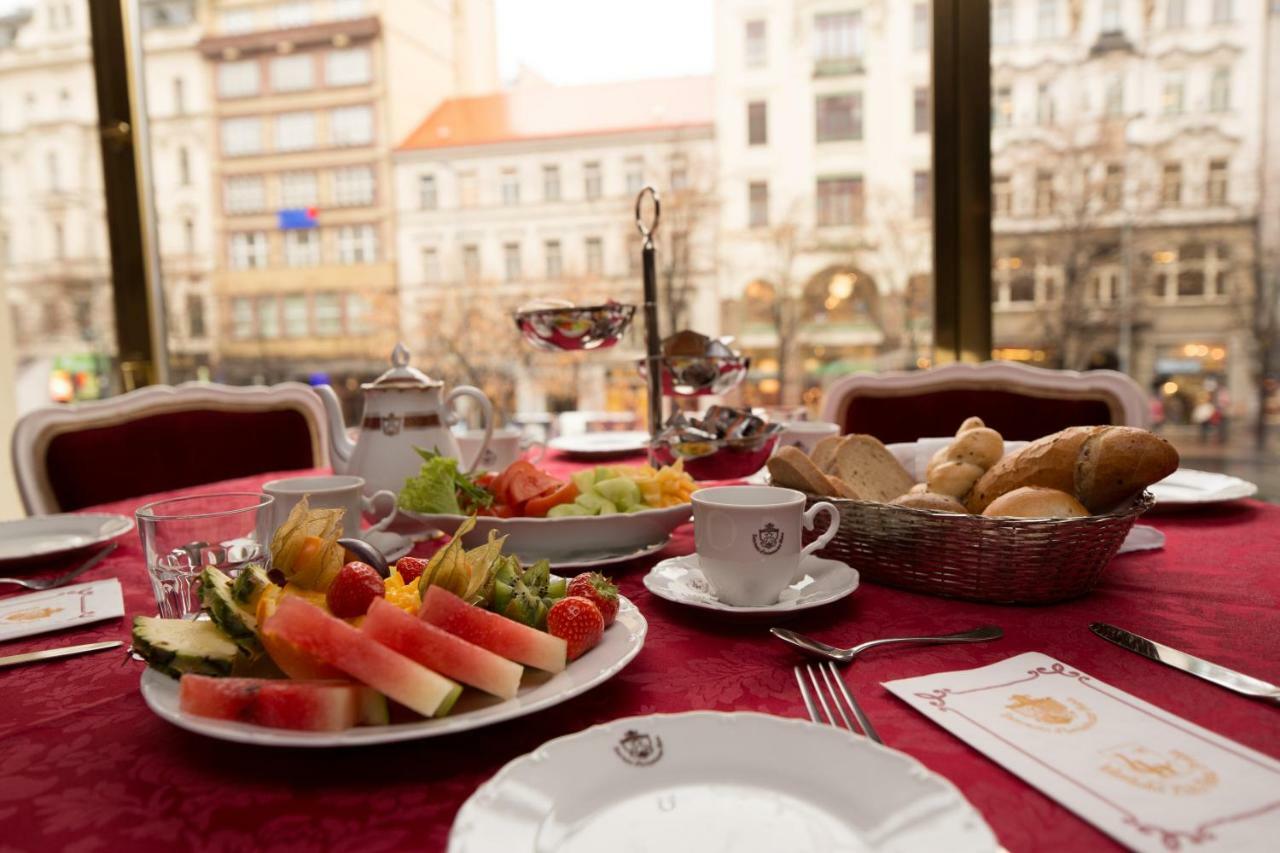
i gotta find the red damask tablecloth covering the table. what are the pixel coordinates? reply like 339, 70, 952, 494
0, 461, 1280, 853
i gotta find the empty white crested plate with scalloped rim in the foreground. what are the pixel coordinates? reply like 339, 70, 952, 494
448, 711, 998, 853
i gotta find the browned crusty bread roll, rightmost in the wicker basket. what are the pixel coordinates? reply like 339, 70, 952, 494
1074, 427, 1178, 512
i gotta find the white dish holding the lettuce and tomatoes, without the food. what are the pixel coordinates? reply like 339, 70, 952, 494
399, 503, 692, 566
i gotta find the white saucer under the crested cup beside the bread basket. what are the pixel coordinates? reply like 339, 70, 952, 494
644, 553, 858, 613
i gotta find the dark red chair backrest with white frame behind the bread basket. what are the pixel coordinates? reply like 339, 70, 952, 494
822, 361, 1151, 442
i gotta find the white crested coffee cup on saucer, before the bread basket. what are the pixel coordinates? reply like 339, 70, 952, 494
692, 485, 840, 606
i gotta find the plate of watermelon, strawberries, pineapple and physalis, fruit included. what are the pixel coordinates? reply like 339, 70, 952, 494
133, 501, 646, 747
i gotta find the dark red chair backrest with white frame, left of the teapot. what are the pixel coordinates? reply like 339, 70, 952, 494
12, 382, 329, 515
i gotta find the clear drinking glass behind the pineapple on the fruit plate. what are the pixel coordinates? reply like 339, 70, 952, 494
134, 492, 275, 619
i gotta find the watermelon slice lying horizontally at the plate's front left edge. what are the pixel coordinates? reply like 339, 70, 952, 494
178, 672, 363, 731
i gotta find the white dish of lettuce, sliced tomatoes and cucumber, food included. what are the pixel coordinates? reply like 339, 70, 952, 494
399, 451, 698, 569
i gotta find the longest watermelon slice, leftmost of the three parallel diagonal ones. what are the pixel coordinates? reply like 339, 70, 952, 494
262, 596, 462, 717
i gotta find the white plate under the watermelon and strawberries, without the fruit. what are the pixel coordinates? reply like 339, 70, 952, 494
142, 596, 649, 747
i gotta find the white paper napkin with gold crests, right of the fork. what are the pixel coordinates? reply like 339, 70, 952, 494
884, 651, 1280, 853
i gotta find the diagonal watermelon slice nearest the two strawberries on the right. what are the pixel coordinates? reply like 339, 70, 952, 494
419, 587, 566, 672
